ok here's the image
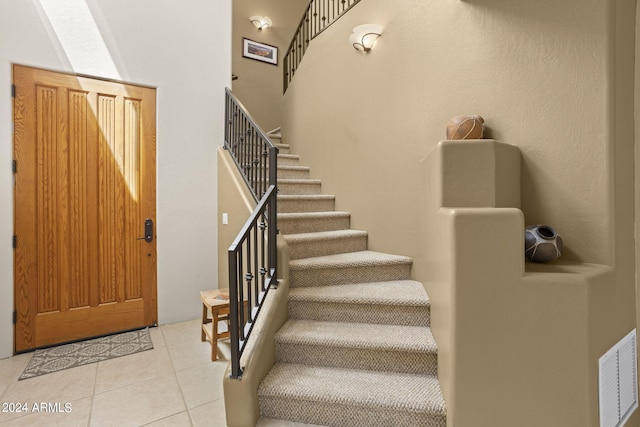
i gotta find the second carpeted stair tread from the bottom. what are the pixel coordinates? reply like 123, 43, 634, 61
276, 320, 437, 353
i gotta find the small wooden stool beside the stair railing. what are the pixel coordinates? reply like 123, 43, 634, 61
200, 289, 229, 361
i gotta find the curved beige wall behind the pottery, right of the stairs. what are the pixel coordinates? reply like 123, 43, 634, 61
283, 0, 612, 263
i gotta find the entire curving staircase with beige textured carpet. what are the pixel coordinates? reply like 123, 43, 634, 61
258, 140, 446, 427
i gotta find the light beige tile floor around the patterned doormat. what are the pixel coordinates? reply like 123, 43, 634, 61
0, 320, 230, 427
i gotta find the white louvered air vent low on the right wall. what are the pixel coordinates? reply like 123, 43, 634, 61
599, 329, 638, 427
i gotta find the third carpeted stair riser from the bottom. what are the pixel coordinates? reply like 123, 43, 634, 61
289, 299, 431, 326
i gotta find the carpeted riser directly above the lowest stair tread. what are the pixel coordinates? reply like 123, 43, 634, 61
276, 340, 438, 375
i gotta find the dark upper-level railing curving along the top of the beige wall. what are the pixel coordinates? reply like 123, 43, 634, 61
283, 0, 360, 92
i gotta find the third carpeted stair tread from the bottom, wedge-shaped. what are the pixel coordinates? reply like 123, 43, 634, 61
289, 280, 431, 308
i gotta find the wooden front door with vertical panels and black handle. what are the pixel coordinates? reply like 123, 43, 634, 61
13, 65, 157, 352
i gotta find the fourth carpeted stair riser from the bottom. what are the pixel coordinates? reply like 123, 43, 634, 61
289, 263, 411, 287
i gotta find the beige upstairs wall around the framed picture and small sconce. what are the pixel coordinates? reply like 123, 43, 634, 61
232, 0, 308, 132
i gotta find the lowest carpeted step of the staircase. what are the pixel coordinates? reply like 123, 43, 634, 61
258, 363, 446, 426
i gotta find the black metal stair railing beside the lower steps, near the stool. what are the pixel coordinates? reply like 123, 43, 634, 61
224, 89, 278, 378
